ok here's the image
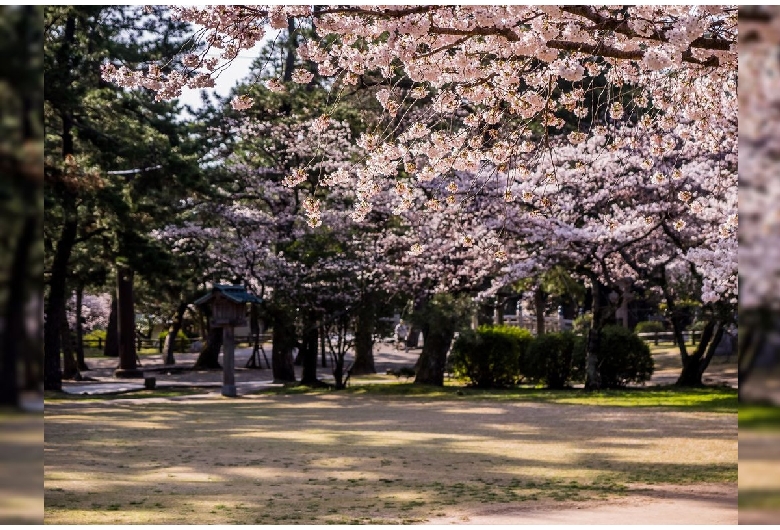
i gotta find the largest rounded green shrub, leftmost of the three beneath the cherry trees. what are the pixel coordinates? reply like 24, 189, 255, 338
449, 326, 532, 388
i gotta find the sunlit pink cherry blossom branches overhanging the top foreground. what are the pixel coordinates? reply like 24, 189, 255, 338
104, 6, 737, 237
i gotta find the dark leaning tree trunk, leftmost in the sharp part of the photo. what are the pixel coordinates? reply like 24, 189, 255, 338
43, 217, 77, 391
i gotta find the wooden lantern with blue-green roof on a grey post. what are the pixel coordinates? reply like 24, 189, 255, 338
195, 285, 261, 397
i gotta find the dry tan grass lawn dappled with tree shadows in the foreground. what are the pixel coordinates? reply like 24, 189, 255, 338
44, 384, 737, 524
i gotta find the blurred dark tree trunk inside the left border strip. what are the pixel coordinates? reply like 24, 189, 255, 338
0, 216, 38, 407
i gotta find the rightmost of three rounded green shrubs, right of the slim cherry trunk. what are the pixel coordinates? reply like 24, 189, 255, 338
598, 326, 654, 388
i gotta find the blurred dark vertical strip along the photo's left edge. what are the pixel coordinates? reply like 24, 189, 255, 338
0, 6, 44, 524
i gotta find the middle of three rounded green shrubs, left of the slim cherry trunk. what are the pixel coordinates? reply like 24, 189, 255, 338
520, 332, 585, 388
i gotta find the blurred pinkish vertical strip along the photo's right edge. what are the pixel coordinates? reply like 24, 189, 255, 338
739, 6, 780, 524
